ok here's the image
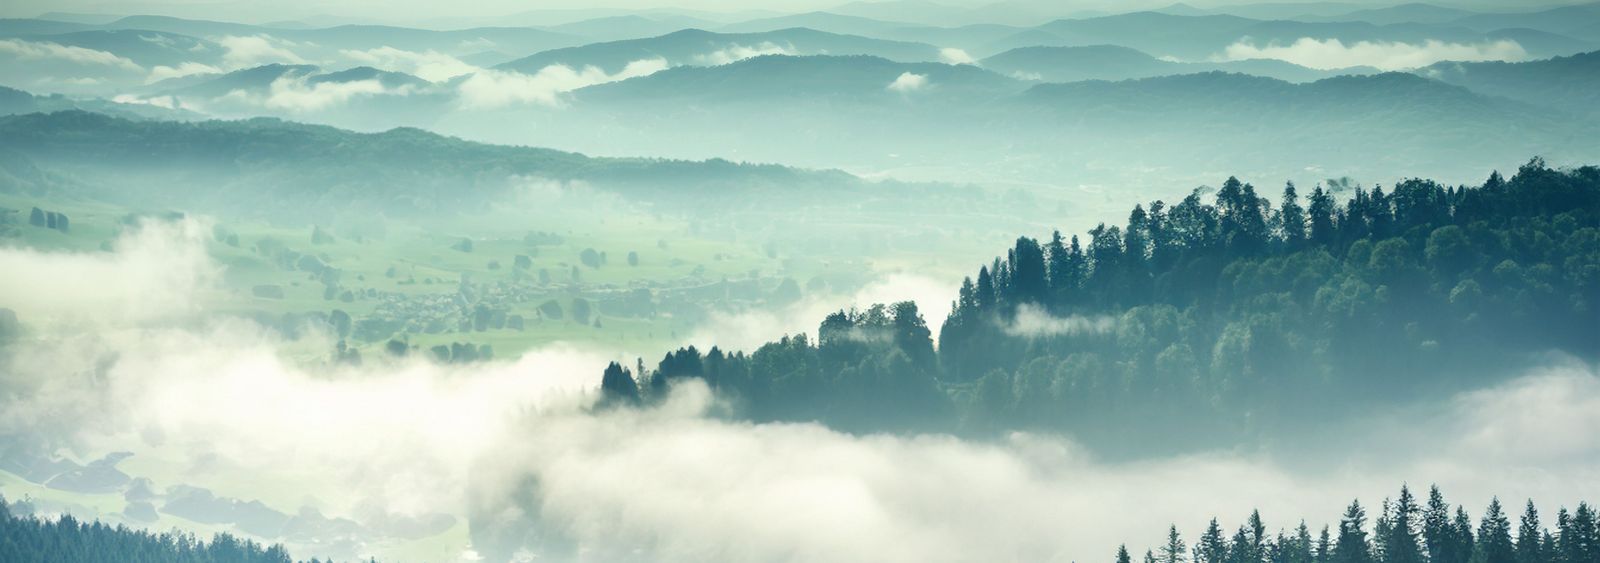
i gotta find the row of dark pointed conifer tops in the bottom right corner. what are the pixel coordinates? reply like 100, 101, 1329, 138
1115, 486, 1600, 563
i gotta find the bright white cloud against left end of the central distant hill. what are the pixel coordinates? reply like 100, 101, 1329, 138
459, 59, 667, 109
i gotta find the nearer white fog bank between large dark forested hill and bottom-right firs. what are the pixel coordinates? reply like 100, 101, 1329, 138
474, 365, 1600, 561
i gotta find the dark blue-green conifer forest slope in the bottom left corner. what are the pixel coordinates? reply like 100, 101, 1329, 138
0, 497, 317, 563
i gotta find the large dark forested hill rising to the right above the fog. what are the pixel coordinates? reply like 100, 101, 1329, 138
603, 160, 1600, 448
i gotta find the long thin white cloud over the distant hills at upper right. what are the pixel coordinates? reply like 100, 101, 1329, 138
1213, 37, 1528, 70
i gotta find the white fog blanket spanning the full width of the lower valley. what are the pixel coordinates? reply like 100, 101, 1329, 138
0, 221, 1600, 561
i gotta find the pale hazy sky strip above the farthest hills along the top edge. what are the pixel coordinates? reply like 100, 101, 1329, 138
0, 0, 1573, 22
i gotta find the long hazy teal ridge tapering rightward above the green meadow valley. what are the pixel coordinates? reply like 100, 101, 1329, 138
0, 110, 880, 214
